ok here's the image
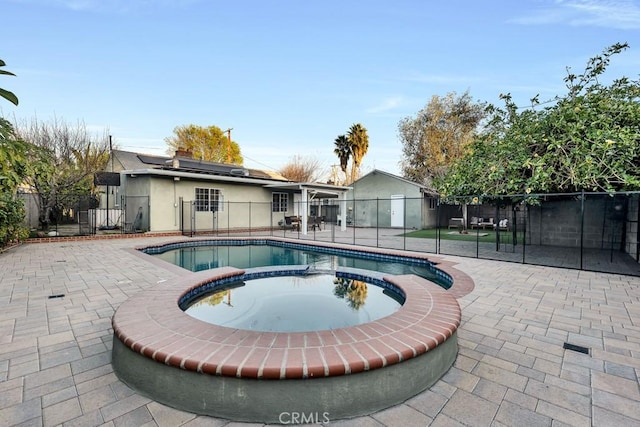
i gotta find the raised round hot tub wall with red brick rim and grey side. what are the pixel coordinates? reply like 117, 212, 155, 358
113, 239, 464, 423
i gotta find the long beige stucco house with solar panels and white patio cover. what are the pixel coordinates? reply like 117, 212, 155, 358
100, 150, 349, 233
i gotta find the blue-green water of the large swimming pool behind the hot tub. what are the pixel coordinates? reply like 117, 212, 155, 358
154, 244, 450, 289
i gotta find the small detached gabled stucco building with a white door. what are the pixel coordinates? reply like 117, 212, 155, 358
347, 169, 438, 229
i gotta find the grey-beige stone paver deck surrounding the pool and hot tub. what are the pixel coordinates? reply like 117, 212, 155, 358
0, 237, 640, 426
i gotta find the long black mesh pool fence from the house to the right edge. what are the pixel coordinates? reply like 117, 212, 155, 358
180, 192, 640, 276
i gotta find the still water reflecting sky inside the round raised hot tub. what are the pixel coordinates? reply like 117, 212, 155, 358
183, 274, 402, 332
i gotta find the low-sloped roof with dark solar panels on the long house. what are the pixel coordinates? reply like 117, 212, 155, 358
112, 150, 288, 182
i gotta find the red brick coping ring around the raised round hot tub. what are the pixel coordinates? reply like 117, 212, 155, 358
112, 242, 473, 379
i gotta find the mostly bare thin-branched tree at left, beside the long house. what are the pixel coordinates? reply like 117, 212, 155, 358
15, 118, 110, 229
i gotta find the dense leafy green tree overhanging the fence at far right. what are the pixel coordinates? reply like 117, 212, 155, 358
438, 43, 640, 195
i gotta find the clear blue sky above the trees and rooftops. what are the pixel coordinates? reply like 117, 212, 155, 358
0, 0, 640, 174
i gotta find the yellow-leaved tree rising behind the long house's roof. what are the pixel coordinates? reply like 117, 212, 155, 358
165, 125, 244, 165
